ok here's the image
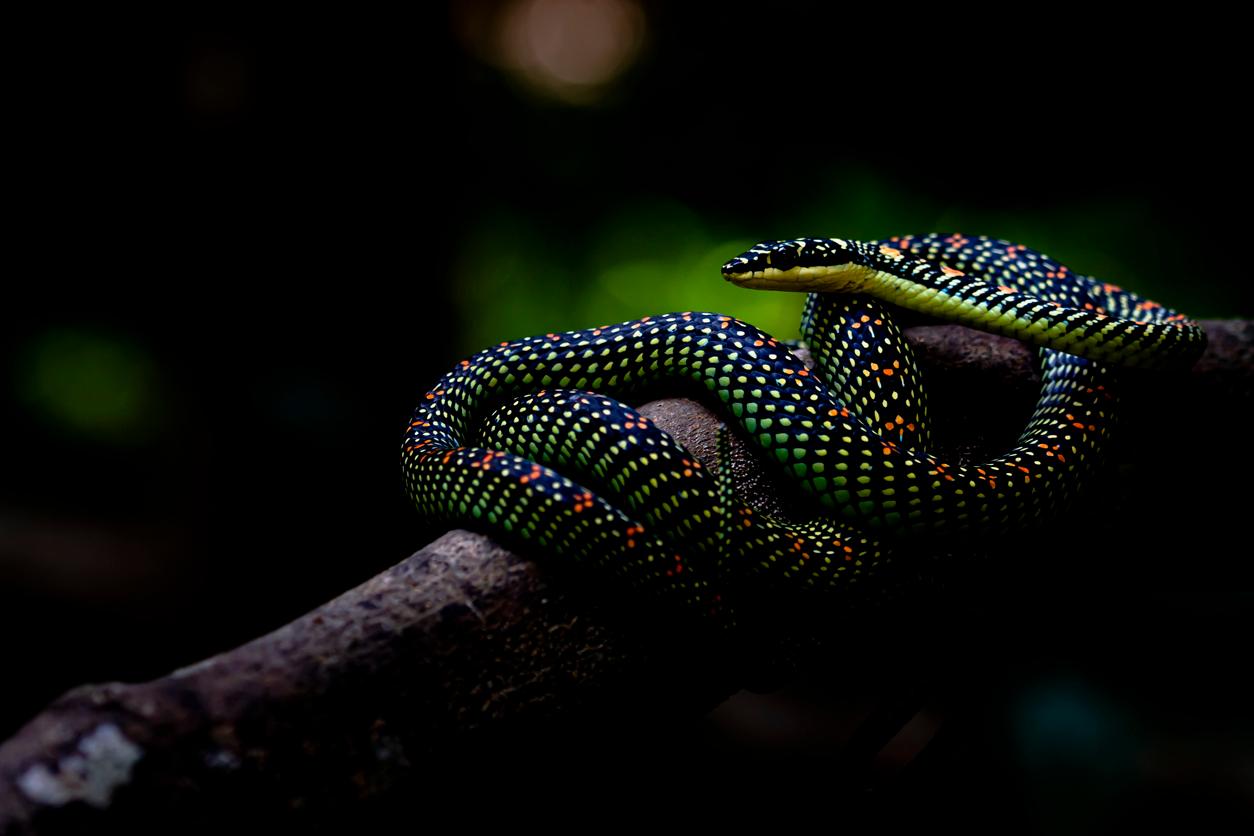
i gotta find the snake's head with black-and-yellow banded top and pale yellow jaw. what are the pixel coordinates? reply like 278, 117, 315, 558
722, 238, 867, 291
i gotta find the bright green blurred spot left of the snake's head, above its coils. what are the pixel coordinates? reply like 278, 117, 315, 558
453, 198, 803, 353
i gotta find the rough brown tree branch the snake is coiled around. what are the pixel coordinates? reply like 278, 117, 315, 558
0, 321, 1254, 833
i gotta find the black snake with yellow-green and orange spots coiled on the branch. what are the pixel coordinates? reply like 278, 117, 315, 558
403, 233, 1205, 620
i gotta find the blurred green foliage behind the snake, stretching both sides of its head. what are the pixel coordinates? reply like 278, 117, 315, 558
451, 164, 1225, 353
